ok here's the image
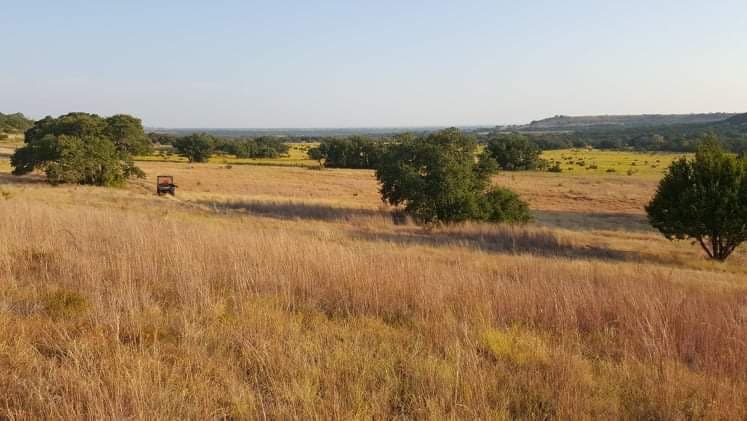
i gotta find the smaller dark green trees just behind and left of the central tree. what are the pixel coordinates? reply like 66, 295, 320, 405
308, 136, 387, 169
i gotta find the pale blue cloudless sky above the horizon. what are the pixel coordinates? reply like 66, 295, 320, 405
0, 0, 747, 128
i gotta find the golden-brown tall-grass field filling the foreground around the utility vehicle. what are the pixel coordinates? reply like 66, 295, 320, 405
0, 147, 747, 420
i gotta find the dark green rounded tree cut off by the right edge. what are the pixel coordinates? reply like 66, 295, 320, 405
646, 138, 747, 261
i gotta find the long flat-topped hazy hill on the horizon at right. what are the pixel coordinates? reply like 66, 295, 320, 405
516, 113, 738, 131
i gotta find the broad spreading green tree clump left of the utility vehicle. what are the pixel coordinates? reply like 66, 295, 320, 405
11, 113, 151, 186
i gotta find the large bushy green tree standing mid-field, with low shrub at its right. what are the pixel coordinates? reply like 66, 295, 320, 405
376, 128, 530, 224
